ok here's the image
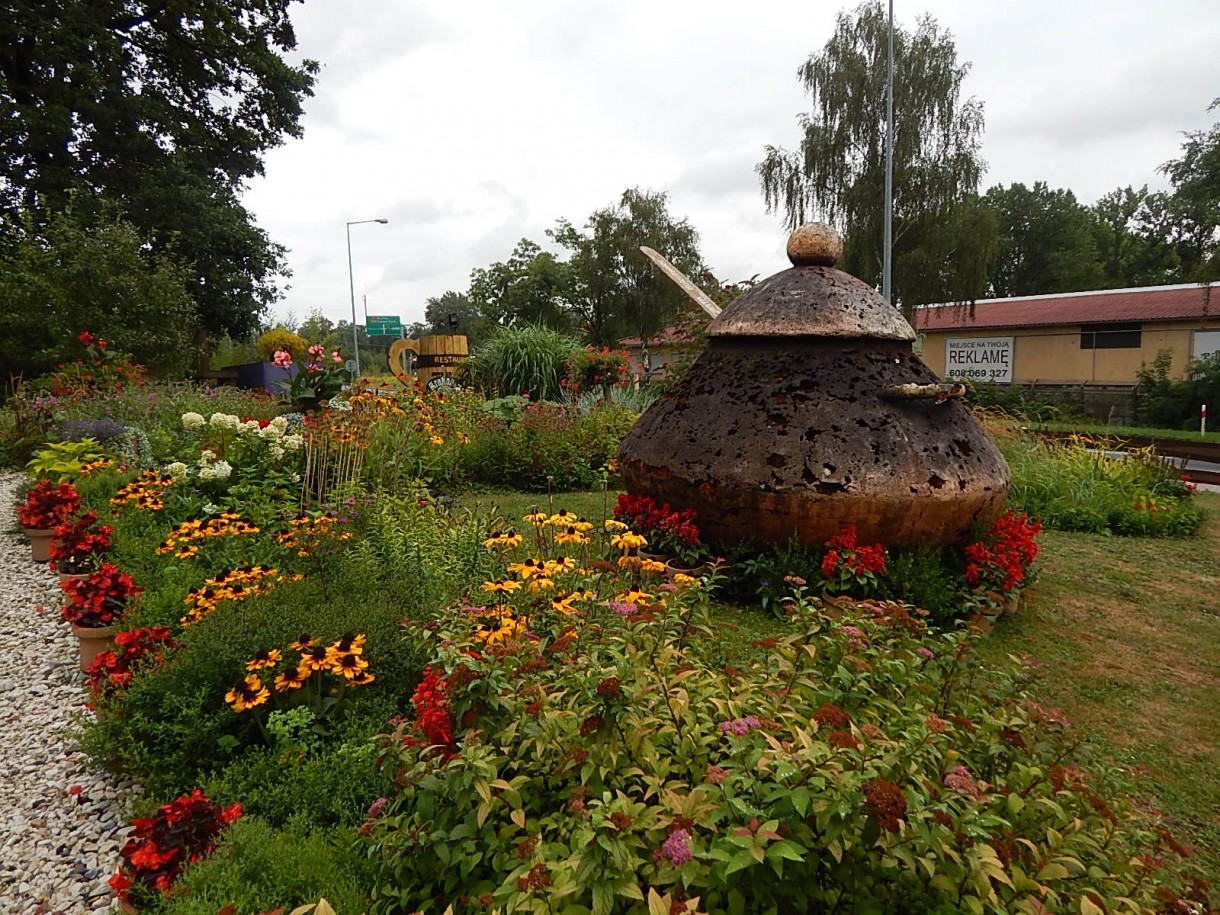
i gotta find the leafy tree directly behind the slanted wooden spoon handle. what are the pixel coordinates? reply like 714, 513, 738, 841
548, 188, 705, 346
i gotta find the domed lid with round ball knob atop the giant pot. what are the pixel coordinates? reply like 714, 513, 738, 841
708, 222, 915, 340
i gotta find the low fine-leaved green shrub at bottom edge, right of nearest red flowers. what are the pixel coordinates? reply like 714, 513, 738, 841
148, 816, 370, 915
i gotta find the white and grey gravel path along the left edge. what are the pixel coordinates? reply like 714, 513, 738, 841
0, 473, 133, 915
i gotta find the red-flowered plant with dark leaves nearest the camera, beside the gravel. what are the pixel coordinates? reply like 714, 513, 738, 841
110, 788, 242, 905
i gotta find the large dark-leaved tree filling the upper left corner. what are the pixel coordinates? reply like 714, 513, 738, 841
0, 0, 317, 344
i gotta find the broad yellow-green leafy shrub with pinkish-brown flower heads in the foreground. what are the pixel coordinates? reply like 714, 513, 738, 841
364, 582, 1197, 914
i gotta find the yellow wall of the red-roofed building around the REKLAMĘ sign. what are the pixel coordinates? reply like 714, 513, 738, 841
920, 318, 1220, 384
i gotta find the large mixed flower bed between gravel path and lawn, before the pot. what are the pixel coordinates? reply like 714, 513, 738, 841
4, 348, 1215, 913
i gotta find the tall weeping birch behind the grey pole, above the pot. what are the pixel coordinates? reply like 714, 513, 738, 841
756, 0, 996, 309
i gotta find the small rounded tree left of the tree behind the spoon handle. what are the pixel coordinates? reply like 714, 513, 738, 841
468, 238, 572, 331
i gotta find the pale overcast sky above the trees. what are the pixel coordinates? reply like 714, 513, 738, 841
245, 0, 1220, 323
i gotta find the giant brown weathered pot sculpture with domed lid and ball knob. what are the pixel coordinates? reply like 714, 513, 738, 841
619, 224, 1009, 547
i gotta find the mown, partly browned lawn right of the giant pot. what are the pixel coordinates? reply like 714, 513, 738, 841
983, 493, 1220, 874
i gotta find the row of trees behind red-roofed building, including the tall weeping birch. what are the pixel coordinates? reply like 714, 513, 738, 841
756, 0, 1220, 311
